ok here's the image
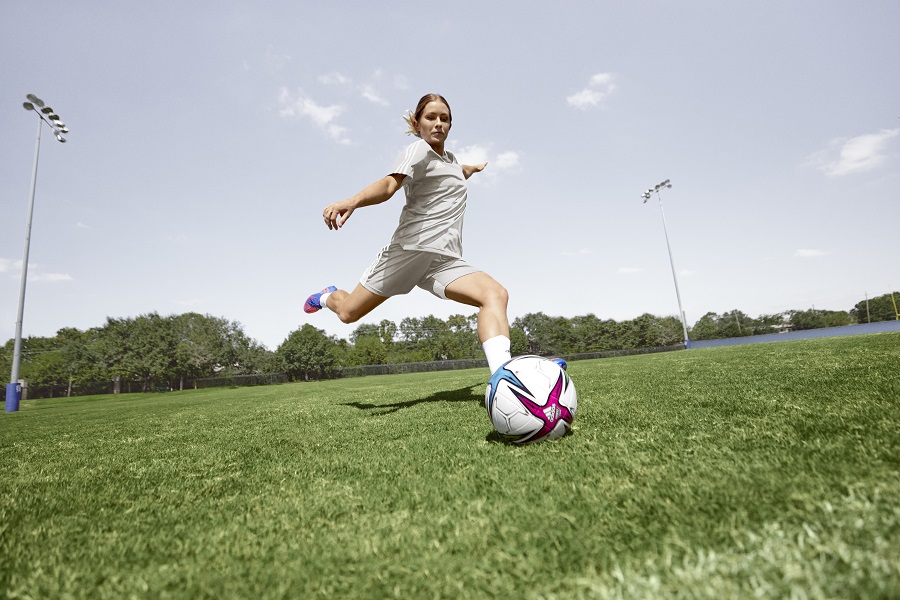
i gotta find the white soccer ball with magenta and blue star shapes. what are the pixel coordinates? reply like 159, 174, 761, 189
484, 355, 578, 444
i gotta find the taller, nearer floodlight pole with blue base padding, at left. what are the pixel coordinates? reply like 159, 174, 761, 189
6, 94, 69, 412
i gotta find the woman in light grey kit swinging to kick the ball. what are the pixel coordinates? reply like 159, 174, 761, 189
303, 94, 510, 373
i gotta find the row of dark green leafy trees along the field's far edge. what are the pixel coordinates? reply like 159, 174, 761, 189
0, 293, 900, 397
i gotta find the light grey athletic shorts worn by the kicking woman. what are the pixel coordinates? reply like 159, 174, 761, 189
359, 244, 480, 300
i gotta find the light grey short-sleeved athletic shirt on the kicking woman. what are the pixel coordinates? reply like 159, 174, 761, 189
391, 140, 467, 258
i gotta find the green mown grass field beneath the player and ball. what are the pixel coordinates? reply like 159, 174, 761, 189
0, 333, 900, 599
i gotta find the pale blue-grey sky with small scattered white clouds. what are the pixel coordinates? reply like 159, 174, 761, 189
0, 0, 900, 350
